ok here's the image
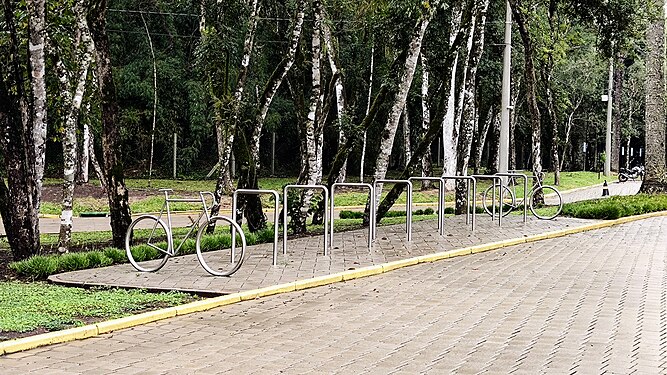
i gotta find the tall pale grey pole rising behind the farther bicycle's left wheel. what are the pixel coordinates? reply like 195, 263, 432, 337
498, 1, 512, 173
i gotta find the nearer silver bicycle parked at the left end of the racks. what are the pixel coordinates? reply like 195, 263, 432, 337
125, 189, 246, 276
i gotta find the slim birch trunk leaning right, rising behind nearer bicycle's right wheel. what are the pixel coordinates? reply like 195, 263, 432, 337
211, 0, 259, 209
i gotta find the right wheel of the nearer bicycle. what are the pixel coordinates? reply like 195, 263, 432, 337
195, 216, 246, 276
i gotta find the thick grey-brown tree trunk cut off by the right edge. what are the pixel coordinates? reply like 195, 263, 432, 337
641, 0, 667, 193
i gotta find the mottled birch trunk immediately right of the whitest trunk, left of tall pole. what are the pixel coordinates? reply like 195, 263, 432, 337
456, 0, 489, 213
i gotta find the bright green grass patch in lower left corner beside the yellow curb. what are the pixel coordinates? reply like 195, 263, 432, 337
0, 282, 195, 340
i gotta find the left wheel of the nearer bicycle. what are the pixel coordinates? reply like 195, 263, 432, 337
125, 215, 172, 272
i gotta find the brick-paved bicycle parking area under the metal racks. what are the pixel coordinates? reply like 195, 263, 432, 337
49, 215, 591, 295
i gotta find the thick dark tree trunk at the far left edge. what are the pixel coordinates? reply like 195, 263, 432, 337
0, 0, 46, 260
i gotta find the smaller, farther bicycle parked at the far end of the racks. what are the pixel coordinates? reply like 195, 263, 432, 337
482, 172, 563, 220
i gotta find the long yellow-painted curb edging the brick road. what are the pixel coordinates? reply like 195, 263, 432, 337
0, 211, 667, 356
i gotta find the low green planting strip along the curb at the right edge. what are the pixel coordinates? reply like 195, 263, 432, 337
563, 194, 667, 220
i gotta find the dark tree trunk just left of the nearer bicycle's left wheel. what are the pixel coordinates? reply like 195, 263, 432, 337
88, 0, 132, 248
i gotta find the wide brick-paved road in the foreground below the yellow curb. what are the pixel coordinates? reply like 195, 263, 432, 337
5, 217, 667, 374
